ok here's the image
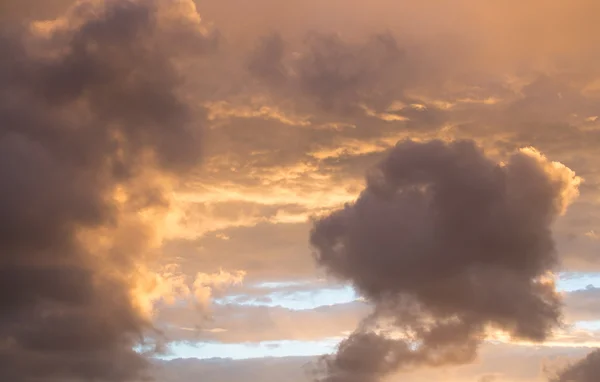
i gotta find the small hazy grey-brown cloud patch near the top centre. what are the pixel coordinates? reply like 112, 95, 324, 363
248, 32, 409, 113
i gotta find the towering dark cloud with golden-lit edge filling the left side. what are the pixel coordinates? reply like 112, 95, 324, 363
0, 0, 213, 382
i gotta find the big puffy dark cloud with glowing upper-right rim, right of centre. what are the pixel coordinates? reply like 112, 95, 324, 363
311, 140, 579, 382
